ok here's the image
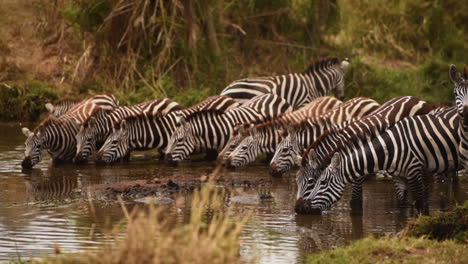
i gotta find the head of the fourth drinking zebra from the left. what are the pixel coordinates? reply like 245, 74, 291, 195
165, 116, 195, 164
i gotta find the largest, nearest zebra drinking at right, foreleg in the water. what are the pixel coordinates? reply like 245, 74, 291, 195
295, 108, 460, 214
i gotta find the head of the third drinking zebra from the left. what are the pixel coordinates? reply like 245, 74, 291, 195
96, 120, 130, 164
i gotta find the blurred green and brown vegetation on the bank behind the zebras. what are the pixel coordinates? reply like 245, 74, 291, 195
0, 0, 468, 121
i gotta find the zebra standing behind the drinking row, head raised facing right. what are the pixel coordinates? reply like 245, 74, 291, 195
221, 57, 349, 109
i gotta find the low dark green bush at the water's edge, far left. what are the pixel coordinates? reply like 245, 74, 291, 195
0, 81, 57, 121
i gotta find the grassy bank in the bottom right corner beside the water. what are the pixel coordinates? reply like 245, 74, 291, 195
304, 202, 468, 264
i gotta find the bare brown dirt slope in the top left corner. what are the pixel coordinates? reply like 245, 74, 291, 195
0, 0, 79, 87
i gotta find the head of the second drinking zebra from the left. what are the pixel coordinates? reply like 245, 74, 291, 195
74, 117, 97, 162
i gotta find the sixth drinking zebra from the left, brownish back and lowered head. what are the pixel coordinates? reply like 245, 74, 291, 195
270, 97, 379, 176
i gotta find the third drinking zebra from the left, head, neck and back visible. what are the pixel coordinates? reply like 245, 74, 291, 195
96, 98, 183, 164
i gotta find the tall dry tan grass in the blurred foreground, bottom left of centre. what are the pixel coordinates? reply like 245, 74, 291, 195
40, 186, 247, 264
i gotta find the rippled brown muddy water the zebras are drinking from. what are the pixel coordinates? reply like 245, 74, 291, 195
0, 124, 468, 263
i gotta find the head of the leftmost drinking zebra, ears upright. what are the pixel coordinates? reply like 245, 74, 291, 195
21, 127, 47, 169
